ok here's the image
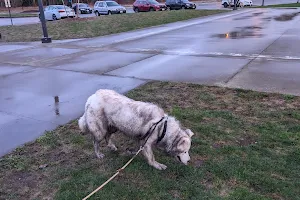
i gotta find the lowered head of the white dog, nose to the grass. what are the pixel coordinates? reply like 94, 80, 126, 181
172, 129, 194, 165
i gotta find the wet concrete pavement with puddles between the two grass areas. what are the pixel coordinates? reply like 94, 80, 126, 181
0, 9, 300, 155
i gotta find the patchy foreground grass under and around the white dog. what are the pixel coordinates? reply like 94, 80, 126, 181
0, 82, 300, 200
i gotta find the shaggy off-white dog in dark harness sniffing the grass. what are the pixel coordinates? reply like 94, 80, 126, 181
78, 90, 193, 170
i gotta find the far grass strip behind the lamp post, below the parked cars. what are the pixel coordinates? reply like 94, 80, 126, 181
0, 10, 224, 42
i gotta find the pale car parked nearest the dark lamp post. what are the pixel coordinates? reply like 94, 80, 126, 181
39, 5, 75, 21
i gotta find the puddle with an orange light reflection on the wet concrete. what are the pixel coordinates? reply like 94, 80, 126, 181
212, 26, 263, 39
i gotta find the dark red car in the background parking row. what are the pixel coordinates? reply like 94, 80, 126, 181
133, 0, 167, 12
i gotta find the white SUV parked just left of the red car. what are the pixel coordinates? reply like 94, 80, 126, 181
94, 1, 126, 16
